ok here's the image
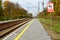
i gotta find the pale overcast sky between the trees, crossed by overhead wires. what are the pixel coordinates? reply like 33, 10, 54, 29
2, 0, 49, 16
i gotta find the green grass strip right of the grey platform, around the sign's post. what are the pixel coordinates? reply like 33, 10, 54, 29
39, 18, 60, 34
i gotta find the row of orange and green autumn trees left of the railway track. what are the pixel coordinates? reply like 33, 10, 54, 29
0, 0, 32, 20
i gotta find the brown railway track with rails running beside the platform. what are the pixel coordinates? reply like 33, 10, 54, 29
0, 19, 31, 38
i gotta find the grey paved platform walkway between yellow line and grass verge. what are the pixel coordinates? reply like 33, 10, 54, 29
19, 19, 51, 40
